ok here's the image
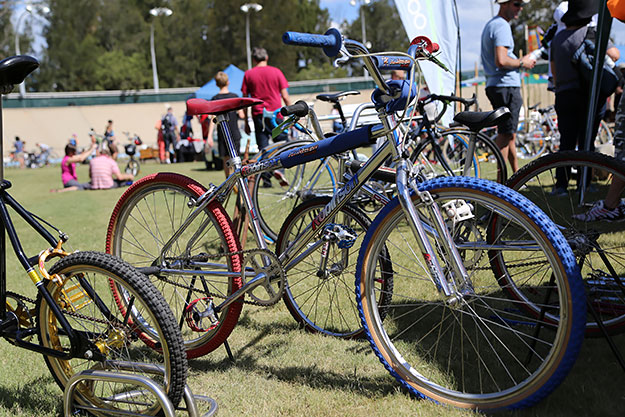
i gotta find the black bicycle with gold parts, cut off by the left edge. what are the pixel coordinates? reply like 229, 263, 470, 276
0, 55, 187, 415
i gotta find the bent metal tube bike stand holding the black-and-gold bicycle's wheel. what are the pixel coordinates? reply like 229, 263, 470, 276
63, 361, 217, 417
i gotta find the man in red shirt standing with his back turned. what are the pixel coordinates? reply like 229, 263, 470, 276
241, 47, 291, 150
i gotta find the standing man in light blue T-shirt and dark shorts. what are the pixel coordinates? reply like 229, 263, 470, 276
481, 0, 536, 172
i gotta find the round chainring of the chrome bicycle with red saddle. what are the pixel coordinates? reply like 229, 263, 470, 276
241, 249, 286, 306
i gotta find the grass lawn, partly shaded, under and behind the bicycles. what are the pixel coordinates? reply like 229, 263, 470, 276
0, 162, 625, 417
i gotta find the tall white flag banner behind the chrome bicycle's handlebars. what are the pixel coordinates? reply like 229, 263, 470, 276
395, 0, 458, 124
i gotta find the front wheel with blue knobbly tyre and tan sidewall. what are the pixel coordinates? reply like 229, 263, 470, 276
356, 177, 586, 410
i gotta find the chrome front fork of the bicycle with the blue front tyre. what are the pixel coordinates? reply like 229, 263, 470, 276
397, 160, 473, 304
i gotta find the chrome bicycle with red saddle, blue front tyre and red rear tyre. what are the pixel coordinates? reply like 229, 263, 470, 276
106, 29, 585, 409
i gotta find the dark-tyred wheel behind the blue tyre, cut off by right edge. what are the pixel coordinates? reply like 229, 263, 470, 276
506, 151, 625, 336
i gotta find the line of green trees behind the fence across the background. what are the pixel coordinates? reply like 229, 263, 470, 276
0, 0, 558, 91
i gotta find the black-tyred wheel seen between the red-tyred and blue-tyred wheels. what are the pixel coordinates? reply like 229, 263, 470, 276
276, 197, 393, 338
